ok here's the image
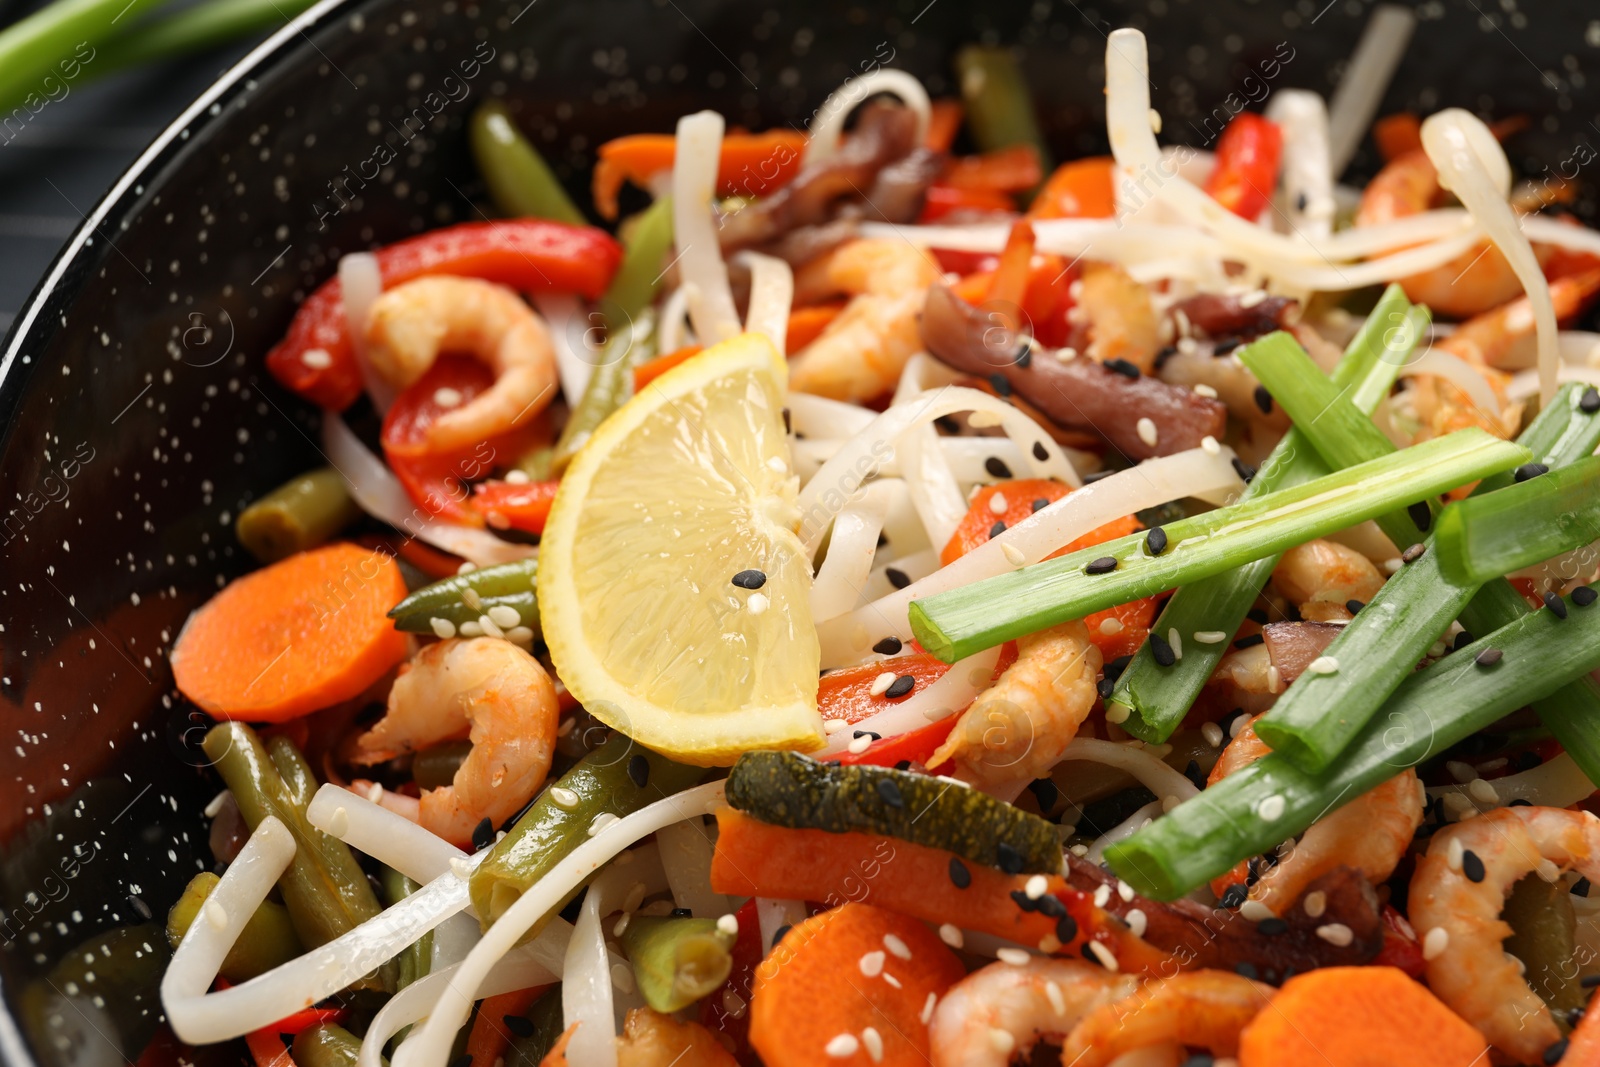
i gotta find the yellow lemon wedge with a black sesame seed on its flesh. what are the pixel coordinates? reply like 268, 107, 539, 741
538, 334, 824, 766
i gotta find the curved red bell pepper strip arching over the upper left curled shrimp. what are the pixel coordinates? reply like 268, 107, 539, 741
267, 219, 622, 411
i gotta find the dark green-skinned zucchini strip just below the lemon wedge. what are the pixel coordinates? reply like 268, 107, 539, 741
726, 752, 1061, 875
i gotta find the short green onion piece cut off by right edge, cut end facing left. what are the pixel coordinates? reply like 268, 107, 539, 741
1435, 456, 1600, 584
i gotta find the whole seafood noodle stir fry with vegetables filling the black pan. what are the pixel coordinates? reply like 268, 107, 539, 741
147, 20, 1600, 1067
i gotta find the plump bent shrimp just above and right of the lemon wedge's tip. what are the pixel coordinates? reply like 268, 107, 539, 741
789, 237, 939, 403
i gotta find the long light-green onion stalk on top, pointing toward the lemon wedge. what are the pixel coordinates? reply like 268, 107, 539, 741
910, 429, 1528, 662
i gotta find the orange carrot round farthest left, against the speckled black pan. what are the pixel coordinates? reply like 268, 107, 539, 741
173, 542, 406, 723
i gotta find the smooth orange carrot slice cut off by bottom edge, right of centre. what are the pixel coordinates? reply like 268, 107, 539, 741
1238, 966, 1484, 1067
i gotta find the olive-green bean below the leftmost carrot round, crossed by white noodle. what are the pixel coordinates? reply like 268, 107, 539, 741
202, 723, 379, 979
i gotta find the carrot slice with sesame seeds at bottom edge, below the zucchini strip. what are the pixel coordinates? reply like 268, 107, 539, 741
750, 904, 966, 1067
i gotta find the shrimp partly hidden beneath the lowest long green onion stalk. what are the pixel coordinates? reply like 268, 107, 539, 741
1206, 720, 1422, 915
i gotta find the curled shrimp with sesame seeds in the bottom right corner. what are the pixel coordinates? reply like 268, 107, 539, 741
1408, 808, 1600, 1064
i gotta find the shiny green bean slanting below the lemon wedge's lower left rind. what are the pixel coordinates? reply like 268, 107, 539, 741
470, 733, 706, 929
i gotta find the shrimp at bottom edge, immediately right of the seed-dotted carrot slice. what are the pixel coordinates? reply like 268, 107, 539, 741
928, 957, 1139, 1067
